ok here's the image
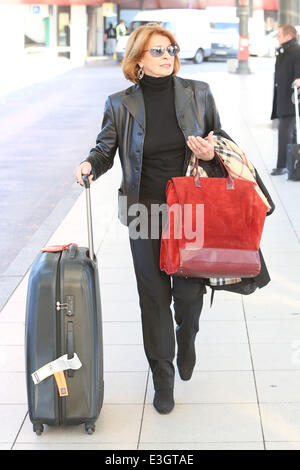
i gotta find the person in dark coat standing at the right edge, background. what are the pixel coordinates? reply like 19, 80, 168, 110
271, 24, 300, 176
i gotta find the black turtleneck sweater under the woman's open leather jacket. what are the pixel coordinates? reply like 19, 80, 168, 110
139, 75, 186, 202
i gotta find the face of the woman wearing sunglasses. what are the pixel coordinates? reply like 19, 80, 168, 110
139, 34, 175, 77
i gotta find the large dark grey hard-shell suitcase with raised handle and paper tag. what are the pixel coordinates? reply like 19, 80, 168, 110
25, 178, 104, 435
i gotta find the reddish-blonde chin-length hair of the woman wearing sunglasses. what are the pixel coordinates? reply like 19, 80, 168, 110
122, 23, 180, 83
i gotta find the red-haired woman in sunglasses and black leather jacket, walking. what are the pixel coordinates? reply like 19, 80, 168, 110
74, 23, 222, 413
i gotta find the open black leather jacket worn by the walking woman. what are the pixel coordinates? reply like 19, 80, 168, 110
85, 76, 221, 225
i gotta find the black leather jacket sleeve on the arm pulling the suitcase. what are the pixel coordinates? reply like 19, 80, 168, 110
84, 97, 118, 180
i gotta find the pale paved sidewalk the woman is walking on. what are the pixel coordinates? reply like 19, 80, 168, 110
0, 57, 300, 450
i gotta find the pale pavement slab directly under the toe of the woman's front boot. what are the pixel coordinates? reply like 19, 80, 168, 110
141, 403, 262, 444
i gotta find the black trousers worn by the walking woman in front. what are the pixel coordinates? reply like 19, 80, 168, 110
129, 204, 206, 390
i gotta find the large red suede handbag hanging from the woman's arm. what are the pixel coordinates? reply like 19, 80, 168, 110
160, 157, 267, 278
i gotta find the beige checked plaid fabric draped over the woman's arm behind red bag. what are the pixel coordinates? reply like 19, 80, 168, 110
186, 136, 271, 286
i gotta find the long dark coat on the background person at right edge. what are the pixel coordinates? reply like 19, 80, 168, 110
271, 38, 300, 119
